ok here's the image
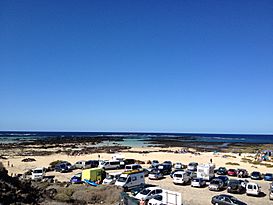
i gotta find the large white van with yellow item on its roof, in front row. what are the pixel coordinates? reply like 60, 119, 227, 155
115, 170, 145, 191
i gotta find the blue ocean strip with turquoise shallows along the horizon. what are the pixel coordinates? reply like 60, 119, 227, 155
0, 131, 273, 146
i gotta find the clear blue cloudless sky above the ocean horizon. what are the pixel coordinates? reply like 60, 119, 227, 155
0, 0, 273, 133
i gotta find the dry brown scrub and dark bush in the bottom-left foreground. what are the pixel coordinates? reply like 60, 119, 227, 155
0, 163, 122, 205
